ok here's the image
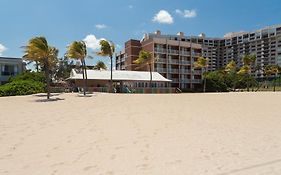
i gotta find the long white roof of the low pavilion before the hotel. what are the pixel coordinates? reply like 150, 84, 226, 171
69, 69, 171, 82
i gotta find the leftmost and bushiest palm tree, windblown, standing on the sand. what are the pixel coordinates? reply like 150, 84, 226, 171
23, 37, 58, 99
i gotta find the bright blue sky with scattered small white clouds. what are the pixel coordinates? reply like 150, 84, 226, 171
0, 0, 281, 66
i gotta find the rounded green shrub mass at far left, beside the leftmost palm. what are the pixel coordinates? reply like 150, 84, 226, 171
0, 80, 45, 97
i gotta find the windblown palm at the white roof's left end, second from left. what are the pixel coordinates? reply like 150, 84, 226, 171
66, 41, 88, 95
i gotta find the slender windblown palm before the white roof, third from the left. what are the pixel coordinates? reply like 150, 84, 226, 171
97, 40, 115, 92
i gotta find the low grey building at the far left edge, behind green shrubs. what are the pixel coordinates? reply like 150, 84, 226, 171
0, 57, 25, 85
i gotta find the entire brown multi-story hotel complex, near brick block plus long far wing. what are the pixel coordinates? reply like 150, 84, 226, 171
116, 25, 281, 89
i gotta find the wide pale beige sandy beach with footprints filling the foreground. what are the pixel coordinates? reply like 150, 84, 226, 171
0, 92, 281, 175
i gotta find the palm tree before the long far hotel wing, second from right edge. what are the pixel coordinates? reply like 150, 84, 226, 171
238, 54, 256, 92
